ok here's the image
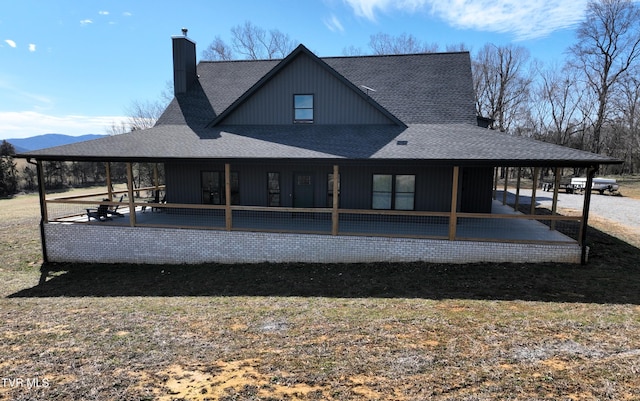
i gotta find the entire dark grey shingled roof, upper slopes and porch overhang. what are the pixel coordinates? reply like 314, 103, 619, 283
21, 46, 618, 166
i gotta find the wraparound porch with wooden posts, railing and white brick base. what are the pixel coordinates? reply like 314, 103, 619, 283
33, 163, 588, 263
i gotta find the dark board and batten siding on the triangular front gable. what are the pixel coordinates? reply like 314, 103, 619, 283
221, 55, 393, 125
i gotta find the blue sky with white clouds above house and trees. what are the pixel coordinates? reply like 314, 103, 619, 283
0, 0, 600, 140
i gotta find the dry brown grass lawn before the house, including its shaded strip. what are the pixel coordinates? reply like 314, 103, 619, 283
0, 183, 640, 401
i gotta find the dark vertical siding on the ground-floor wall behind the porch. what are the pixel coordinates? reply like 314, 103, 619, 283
165, 160, 492, 213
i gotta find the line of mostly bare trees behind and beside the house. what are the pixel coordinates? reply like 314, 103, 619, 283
0, 0, 640, 196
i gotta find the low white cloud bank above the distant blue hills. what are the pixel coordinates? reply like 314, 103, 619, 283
0, 111, 126, 139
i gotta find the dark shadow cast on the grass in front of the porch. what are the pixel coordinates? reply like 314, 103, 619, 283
10, 225, 640, 304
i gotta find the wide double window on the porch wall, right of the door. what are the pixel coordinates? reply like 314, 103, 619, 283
371, 174, 416, 210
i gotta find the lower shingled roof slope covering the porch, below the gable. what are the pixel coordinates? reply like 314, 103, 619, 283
18, 124, 619, 167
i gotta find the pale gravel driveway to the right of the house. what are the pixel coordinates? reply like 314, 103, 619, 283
497, 189, 640, 232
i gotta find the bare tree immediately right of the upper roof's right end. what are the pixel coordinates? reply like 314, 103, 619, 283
472, 44, 532, 132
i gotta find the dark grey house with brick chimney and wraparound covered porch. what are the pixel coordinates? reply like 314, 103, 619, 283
21, 29, 618, 263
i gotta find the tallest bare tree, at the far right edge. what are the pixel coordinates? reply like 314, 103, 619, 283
569, 0, 640, 153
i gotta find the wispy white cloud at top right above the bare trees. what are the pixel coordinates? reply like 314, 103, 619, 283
344, 0, 588, 40
